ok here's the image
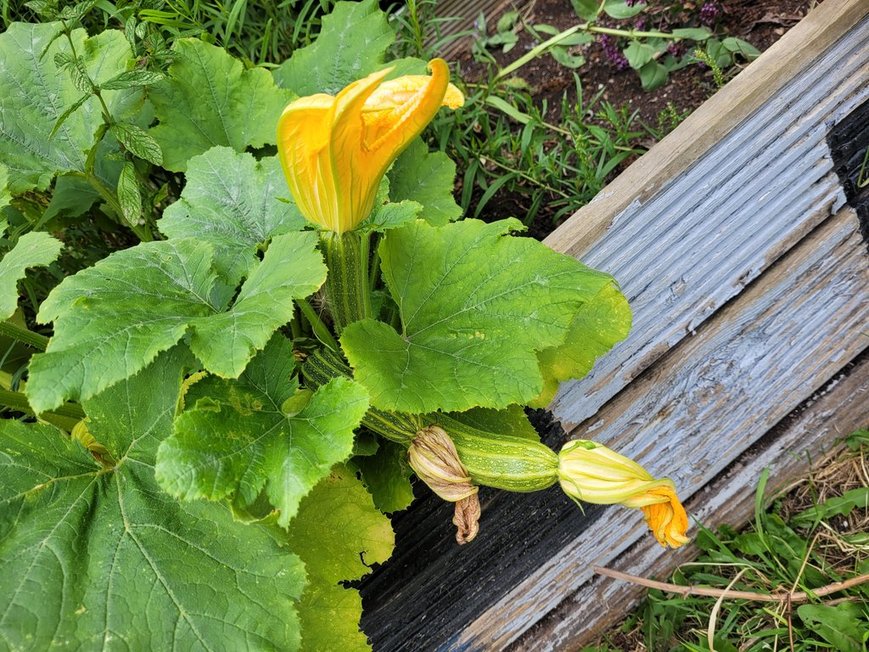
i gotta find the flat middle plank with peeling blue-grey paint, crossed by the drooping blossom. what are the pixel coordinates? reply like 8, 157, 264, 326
450, 209, 869, 649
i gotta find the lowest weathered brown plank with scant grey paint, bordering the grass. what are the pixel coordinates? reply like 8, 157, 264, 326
514, 353, 869, 650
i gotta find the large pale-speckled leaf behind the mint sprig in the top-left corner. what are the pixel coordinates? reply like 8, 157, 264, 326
0, 23, 142, 195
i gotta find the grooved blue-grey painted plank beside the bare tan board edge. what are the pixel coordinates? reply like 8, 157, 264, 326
547, 14, 869, 424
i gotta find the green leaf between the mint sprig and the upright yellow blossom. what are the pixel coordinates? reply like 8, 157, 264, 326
148, 38, 292, 172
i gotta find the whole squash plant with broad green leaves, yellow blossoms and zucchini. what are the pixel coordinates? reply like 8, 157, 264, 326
0, 0, 687, 650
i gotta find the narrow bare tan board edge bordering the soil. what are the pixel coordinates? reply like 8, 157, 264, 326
544, 0, 869, 257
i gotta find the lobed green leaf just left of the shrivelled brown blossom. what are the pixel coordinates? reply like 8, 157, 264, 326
157, 337, 368, 526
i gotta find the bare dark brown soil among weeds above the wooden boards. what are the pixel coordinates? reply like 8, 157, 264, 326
450, 0, 820, 238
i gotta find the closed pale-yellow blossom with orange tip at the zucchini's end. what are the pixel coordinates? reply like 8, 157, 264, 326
558, 439, 689, 548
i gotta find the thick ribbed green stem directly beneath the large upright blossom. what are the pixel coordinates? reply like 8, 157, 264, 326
321, 231, 372, 335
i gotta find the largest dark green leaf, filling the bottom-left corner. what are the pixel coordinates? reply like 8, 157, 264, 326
0, 353, 305, 651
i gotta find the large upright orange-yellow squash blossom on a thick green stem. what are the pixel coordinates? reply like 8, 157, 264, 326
278, 59, 464, 233
